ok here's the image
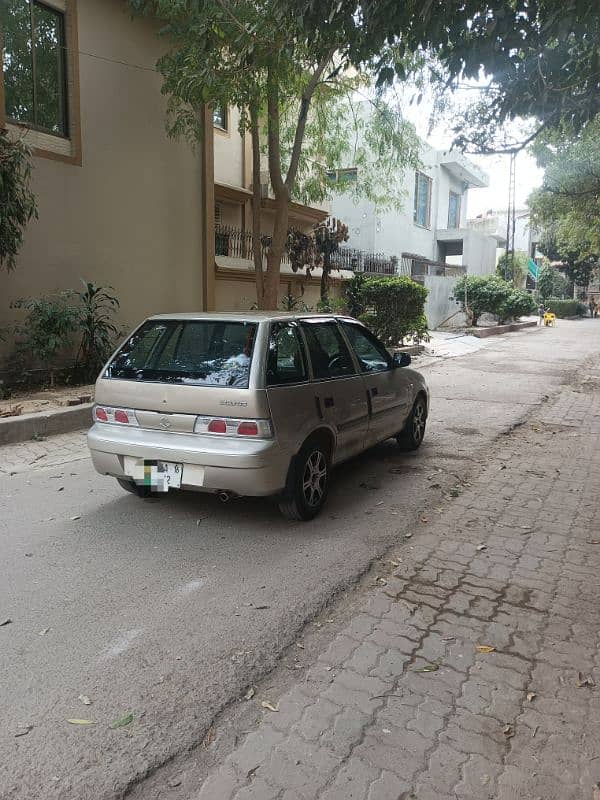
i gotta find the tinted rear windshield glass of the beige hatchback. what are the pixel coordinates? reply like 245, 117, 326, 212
105, 319, 257, 389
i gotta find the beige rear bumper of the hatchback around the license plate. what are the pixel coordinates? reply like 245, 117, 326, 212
88, 423, 290, 497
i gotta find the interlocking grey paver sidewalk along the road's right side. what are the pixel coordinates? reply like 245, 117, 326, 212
192, 370, 600, 800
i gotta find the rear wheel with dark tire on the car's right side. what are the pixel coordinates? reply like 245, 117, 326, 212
279, 439, 330, 522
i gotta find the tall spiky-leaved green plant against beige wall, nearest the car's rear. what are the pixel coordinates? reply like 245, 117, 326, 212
76, 278, 120, 380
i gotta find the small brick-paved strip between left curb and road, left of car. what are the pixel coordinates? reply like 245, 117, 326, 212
0, 430, 89, 475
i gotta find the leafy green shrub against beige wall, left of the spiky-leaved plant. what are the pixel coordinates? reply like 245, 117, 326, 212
11, 291, 79, 386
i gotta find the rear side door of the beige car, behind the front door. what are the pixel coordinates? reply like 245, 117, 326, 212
301, 318, 369, 461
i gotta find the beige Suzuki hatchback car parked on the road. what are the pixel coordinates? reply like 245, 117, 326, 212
88, 312, 429, 520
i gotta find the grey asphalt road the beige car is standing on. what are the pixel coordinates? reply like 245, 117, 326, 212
0, 320, 600, 800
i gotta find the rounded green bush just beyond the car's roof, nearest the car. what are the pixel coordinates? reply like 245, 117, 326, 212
346, 275, 428, 347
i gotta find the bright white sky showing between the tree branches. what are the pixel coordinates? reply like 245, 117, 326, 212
403, 88, 544, 219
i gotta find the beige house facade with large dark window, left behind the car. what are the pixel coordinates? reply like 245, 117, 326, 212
0, 0, 327, 368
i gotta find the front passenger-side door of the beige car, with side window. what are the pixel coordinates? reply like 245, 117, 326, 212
339, 320, 412, 445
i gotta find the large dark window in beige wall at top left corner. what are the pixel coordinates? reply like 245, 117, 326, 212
2, 0, 69, 137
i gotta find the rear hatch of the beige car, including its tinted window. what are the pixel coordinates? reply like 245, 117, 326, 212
96, 318, 269, 433
